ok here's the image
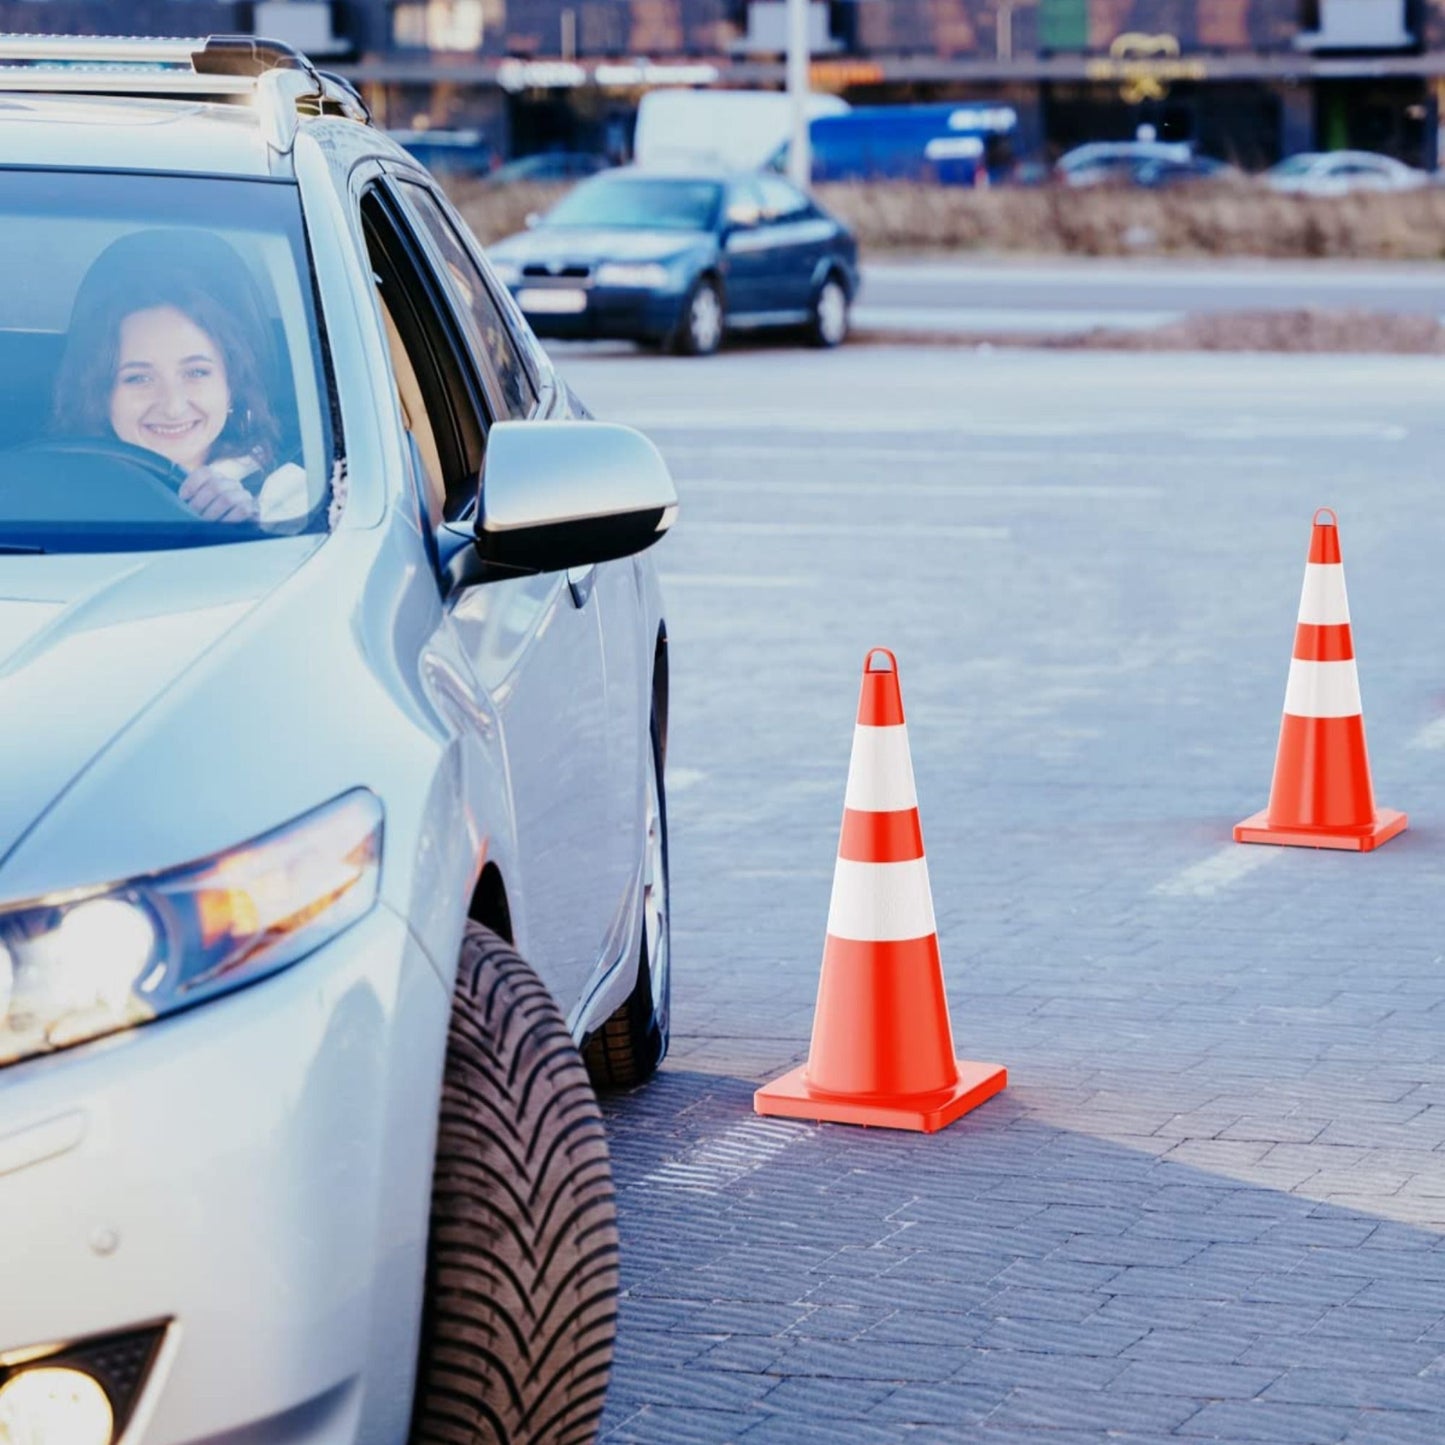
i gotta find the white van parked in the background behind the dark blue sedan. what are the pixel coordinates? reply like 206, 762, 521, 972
633, 90, 848, 171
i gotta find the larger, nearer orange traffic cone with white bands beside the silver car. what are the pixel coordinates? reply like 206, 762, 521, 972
753, 647, 1009, 1134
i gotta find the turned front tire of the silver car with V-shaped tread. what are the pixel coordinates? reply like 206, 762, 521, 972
412, 923, 617, 1445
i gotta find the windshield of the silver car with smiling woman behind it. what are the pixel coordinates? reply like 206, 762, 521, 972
0, 169, 332, 552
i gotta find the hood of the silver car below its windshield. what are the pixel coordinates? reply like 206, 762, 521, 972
0, 536, 322, 858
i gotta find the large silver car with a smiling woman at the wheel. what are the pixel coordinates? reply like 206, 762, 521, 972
0, 36, 676, 1445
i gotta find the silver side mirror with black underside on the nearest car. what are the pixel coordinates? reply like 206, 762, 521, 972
450, 422, 678, 572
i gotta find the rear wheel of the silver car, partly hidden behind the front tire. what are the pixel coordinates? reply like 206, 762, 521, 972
582, 709, 672, 1090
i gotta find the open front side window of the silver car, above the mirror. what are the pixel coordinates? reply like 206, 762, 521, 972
361, 188, 490, 525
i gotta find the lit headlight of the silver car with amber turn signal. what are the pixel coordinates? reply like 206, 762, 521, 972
0, 789, 381, 1066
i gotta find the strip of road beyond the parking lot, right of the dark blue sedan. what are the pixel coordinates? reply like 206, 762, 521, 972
854, 259, 1445, 332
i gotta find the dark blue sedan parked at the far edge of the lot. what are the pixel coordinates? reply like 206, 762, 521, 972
488, 168, 858, 355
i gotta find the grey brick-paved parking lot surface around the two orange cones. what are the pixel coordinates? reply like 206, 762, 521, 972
549, 348, 1445, 1445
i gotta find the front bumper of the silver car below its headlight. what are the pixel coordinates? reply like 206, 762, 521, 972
0, 906, 448, 1445
